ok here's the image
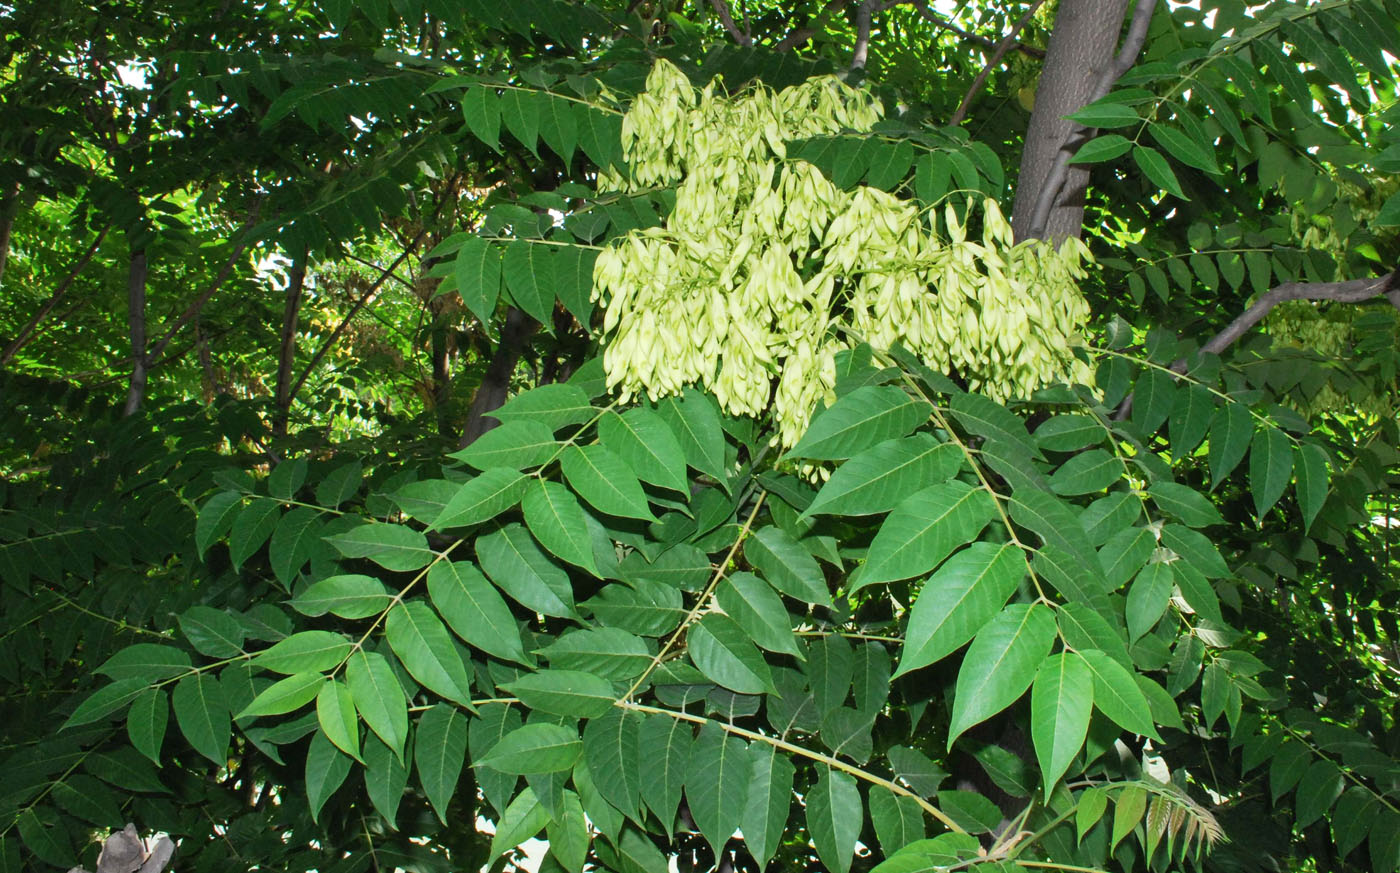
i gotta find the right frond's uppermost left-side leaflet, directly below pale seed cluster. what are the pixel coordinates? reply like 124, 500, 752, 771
787, 385, 931, 460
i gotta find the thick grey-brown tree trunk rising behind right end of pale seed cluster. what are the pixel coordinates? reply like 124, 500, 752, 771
1011, 0, 1127, 243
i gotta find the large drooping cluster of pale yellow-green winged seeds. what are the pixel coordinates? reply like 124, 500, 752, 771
594, 60, 1089, 446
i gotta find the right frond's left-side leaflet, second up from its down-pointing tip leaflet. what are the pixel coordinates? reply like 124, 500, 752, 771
895, 543, 1026, 676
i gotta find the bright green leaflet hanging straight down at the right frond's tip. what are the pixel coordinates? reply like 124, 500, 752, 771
1030, 652, 1093, 803
